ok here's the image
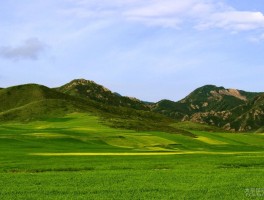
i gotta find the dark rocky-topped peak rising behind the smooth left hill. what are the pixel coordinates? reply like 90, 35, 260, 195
56, 79, 149, 110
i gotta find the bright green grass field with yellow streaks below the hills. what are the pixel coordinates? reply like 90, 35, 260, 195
0, 113, 264, 200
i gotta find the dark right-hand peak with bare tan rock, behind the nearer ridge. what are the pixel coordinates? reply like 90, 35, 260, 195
152, 85, 259, 120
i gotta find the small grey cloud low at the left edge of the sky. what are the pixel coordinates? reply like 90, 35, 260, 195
0, 38, 46, 61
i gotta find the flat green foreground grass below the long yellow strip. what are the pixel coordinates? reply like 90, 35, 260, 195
0, 155, 264, 199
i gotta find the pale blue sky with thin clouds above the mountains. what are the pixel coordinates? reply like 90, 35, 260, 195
0, 0, 264, 102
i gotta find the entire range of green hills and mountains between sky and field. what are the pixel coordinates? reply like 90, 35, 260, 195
0, 79, 264, 134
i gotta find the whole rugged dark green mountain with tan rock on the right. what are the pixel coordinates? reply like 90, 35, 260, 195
152, 85, 264, 131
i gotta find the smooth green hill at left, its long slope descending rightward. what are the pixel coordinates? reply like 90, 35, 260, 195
0, 81, 193, 136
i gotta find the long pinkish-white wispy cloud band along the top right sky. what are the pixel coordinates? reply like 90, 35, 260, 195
63, 0, 264, 32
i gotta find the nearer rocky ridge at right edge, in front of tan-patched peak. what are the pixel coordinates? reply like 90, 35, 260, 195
179, 87, 264, 131
